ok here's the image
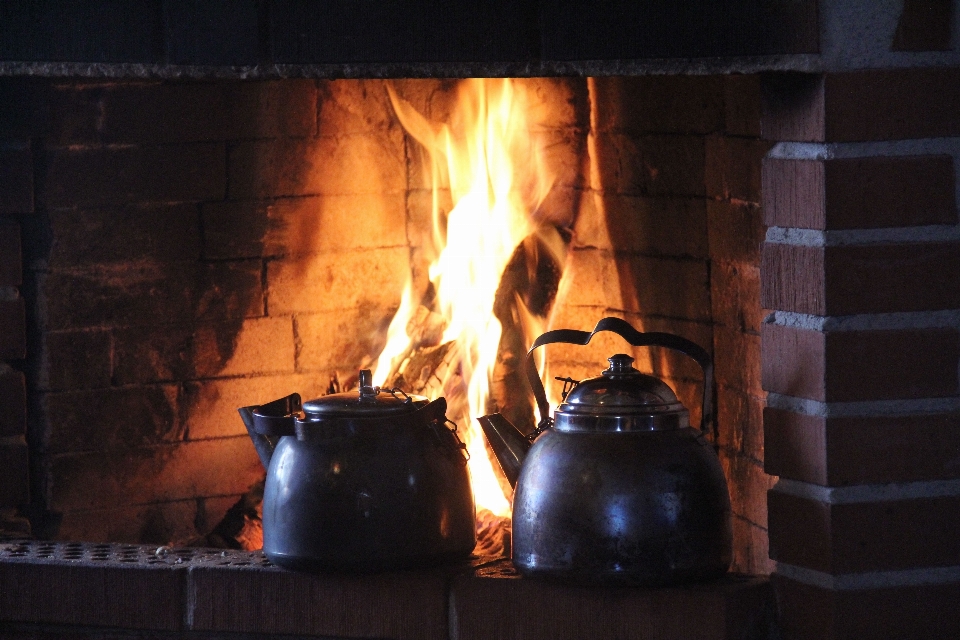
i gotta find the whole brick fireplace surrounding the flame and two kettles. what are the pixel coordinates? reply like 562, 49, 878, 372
0, 0, 960, 637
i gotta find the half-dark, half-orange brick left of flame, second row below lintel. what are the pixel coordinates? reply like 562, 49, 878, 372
229, 131, 406, 199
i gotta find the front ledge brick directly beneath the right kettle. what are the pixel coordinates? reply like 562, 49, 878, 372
450, 561, 774, 640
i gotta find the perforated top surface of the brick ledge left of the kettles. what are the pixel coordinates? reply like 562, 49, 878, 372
0, 540, 273, 568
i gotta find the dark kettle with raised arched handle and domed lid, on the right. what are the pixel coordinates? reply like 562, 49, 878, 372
480, 318, 732, 586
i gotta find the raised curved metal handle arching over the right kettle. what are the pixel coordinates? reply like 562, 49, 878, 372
524, 318, 716, 434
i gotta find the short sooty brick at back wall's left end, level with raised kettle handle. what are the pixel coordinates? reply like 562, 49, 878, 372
36, 330, 113, 390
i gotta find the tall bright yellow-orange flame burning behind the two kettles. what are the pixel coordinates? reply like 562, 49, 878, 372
374, 78, 562, 516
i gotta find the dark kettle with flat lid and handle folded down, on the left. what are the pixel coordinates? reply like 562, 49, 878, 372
239, 369, 476, 571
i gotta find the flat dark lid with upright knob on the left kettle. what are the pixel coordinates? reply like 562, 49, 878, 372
303, 369, 429, 419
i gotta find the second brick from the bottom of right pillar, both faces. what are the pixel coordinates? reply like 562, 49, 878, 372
767, 489, 960, 574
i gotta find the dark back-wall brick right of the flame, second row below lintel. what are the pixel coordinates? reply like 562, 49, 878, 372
590, 133, 706, 197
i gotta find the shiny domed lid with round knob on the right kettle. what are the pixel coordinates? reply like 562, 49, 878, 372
554, 353, 690, 431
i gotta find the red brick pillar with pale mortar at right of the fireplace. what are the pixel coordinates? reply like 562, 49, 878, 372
761, 68, 960, 638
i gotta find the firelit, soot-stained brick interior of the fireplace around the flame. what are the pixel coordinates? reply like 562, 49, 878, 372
7, 75, 773, 573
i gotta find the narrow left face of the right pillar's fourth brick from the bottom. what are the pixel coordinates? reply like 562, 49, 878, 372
760, 324, 826, 400
